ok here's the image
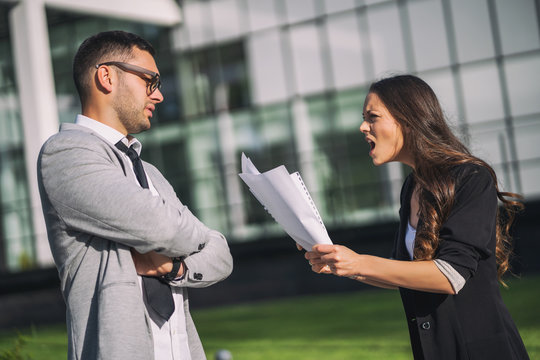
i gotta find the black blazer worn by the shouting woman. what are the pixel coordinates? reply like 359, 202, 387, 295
393, 164, 529, 360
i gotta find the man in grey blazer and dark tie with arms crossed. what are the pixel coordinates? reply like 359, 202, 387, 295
38, 31, 232, 360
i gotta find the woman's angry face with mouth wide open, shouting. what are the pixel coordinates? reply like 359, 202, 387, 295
360, 93, 414, 167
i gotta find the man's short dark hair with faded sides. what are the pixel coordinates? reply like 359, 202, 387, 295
73, 30, 155, 102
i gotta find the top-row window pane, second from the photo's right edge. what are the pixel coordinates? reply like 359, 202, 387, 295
450, 0, 494, 62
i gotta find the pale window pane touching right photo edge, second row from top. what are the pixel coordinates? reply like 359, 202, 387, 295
504, 55, 540, 116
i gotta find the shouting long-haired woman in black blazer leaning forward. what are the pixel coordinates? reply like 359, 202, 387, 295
305, 75, 528, 360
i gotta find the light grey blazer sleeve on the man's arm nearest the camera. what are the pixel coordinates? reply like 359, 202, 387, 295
38, 131, 217, 256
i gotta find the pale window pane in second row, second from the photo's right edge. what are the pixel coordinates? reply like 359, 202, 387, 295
461, 61, 504, 123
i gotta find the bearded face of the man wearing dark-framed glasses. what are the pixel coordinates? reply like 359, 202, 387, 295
112, 48, 163, 134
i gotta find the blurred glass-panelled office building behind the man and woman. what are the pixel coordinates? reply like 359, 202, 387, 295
0, 0, 540, 272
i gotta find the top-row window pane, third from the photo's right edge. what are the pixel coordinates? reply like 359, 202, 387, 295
409, 0, 450, 71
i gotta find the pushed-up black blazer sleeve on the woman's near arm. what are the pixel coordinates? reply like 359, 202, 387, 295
435, 166, 497, 280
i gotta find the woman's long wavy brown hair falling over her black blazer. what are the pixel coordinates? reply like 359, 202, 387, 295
369, 75, 523, 284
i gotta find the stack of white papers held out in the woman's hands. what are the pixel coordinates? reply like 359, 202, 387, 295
239, 153, 332, 250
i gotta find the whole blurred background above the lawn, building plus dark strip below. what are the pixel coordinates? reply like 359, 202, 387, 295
0, 0, 540, 338
